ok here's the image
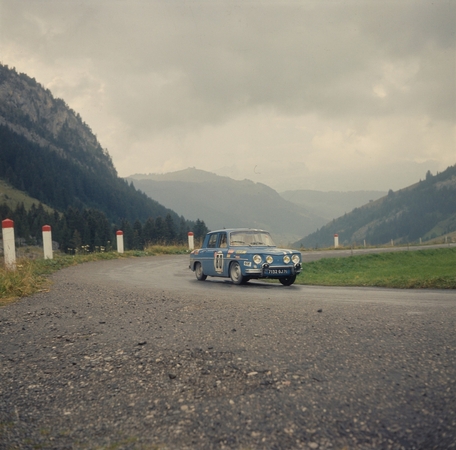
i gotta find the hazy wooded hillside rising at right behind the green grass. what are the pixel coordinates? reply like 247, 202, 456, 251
294, 165, 456, 248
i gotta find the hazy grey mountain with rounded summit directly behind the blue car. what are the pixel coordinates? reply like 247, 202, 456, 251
127, 168, 327, 244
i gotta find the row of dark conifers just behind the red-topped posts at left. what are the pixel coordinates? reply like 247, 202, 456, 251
0, 203, 208, 254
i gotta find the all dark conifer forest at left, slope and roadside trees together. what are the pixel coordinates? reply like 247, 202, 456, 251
0, 125, 207, 251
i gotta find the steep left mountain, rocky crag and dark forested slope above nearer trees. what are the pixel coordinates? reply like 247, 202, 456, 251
0, 64, 204, 251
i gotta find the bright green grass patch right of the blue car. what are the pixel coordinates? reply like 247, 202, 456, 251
296, 248, 456, 289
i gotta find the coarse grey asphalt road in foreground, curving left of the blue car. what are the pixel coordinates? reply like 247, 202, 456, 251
0, 253, 456, 449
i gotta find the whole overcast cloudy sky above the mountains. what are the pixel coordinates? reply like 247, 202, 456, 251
0, 0, 456, 191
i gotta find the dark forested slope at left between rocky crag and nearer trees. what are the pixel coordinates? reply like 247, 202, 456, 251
0, 125, 178, 222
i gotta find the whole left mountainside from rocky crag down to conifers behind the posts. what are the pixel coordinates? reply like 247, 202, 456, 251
0, 64, 207, 252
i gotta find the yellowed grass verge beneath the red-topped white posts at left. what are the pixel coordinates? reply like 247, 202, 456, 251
0, 245, 188, 306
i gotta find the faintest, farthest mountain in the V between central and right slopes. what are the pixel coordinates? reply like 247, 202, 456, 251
279, 189, 386, 222
